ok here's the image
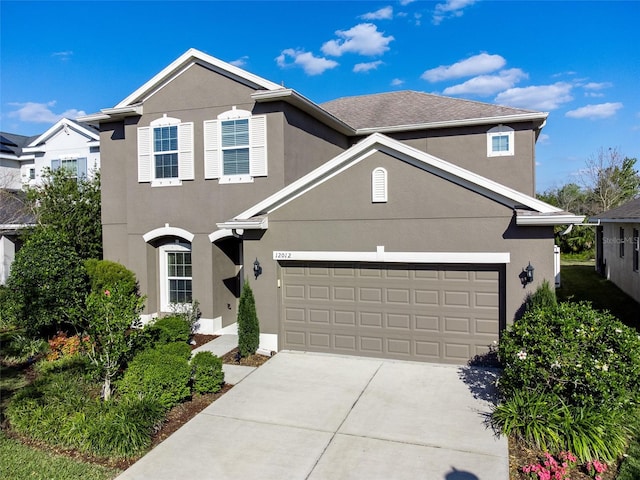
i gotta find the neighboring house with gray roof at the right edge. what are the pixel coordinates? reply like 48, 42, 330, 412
590, 198, 640, 302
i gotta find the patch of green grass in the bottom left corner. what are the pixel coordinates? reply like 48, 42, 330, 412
0, 431, 121, 480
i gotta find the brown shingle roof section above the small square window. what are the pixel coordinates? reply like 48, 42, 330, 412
320, 90, 540, 129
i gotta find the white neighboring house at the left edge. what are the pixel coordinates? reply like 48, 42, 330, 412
0, 118, 100, 190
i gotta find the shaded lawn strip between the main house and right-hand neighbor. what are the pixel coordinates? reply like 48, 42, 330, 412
556, 261, 640, 331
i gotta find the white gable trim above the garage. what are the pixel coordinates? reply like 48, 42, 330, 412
218, 133, 584, 228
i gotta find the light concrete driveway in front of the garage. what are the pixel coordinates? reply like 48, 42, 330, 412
118, 351, 509, 480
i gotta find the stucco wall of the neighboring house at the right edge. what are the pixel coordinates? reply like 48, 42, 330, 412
602, 223, 640, 302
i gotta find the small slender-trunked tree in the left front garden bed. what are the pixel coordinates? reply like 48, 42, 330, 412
86, 281, 144, 401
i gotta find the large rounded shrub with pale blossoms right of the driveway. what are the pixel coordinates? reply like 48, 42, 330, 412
498, 303, 640, 410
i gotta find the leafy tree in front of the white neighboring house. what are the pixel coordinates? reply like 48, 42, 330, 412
27, 168, 102, 260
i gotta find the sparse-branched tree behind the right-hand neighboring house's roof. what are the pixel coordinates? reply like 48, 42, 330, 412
582, 148, 640, 213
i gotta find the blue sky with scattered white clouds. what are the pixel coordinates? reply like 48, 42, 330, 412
0, 0, 640, 191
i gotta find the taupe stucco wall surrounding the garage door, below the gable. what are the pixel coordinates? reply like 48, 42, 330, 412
244, 153, 554, 333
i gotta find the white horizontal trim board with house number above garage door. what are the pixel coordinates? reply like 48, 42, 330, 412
273, 247, 511, 264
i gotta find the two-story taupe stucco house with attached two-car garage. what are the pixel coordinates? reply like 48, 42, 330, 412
81, 49, 583, 363
